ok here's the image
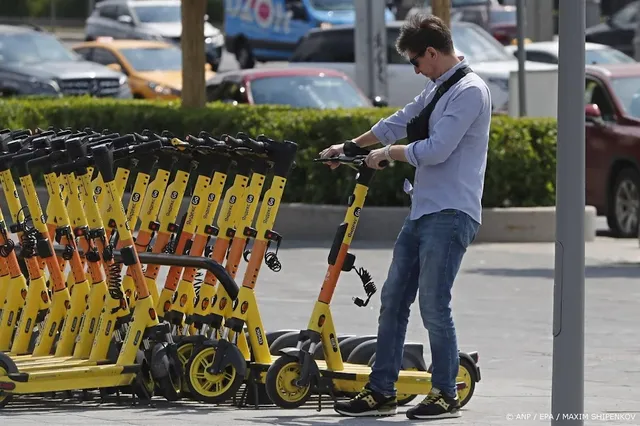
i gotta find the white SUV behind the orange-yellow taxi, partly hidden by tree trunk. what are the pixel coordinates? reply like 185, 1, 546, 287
85, 0, 224, 71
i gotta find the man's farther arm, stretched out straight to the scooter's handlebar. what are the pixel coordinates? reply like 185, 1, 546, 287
353, 88, 427, 147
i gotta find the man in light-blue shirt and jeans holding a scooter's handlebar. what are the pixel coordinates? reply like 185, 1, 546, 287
321, 11, 491, 419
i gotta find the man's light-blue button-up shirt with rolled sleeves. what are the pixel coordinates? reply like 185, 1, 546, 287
371, 58, 491, 223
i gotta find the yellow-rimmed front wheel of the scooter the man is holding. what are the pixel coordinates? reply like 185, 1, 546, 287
265, 355, 312, 408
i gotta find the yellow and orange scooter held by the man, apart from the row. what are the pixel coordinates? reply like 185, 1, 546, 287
265, 141, 480, 408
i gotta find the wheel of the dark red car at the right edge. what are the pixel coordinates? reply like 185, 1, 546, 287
607, 167, 640, 238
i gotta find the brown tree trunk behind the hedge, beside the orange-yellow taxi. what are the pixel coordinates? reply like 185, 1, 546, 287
181, 0, 207, 108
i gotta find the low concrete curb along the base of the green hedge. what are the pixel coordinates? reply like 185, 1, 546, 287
0, 188, 597, 243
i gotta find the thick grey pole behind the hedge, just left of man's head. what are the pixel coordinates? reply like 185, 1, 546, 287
354, 0, 389, 99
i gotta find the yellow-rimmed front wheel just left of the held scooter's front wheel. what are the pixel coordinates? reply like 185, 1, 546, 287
185, 343, 247, 404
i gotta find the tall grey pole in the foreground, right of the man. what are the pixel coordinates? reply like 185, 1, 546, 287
551, 1, 585, 425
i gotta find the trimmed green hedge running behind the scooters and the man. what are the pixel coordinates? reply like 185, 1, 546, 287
0, 98, 556, 207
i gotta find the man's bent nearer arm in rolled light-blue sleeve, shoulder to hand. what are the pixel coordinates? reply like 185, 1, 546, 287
396, 86, 486, 167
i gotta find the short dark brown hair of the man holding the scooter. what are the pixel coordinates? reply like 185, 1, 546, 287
396, 13, 454, 55
